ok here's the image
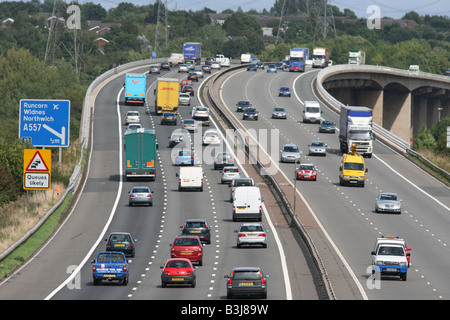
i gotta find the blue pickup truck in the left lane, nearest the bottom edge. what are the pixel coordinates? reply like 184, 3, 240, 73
91, 251, 131, 286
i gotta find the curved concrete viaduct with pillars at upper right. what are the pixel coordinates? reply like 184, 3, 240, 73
317, 65, 450, 142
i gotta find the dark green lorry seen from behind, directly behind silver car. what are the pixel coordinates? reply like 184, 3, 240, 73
125, 128, 158, 180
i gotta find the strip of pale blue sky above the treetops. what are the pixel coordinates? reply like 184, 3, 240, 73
73, 0, 450, 19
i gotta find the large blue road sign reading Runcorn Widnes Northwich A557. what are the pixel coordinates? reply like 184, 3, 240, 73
19, 99, 70, 147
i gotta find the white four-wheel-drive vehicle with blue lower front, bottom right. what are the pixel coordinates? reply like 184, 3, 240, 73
371, 237, 411, 281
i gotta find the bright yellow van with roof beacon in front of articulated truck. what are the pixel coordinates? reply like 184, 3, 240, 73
339, 144, 368, 187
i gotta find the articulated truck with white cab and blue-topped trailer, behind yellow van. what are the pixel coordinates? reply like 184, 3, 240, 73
339, 105, 373, 158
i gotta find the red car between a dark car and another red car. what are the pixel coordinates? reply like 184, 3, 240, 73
170, 236, 203, 266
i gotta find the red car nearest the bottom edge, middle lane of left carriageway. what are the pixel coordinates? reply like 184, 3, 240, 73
161, 258, 196, 288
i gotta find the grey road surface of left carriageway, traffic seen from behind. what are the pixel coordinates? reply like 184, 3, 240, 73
0, 64, 322, 300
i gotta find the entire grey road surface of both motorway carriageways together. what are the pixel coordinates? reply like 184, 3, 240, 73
0, 63, 450, 300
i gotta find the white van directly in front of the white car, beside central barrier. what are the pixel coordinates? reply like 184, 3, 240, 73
233, 186, 264, 221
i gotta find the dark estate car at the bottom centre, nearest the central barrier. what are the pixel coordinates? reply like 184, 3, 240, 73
225, 267, 269, 299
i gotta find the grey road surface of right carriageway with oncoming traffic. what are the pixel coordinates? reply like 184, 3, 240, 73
222, 66, 450, 300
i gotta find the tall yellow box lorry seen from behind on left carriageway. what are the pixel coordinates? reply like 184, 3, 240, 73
155, 78, 180, 115
